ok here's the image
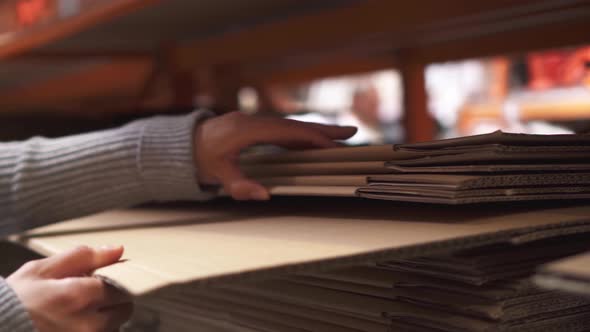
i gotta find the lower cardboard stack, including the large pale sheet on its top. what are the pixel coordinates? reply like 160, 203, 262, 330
6, 198, 590, 332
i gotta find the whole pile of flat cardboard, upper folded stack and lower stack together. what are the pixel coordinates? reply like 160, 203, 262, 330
0, 132, 590, 332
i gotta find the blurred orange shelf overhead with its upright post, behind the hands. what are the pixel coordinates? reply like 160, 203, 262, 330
0, 0, 590, 141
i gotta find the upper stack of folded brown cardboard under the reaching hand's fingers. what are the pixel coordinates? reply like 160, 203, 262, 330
242, 132, 590, 204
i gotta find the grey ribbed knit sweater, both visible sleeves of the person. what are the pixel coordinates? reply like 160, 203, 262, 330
0, 111, 216, 332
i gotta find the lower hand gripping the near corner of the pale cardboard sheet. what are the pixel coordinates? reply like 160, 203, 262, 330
6, 247, 133, 332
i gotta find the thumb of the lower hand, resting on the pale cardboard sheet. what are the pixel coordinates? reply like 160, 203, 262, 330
42, 246, 124, 279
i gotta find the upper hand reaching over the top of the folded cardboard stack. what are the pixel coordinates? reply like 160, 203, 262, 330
194, 112, 356, 200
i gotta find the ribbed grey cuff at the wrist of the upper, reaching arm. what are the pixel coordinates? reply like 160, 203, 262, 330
137, 111, 212, 201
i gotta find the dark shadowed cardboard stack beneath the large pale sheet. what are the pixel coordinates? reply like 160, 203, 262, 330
139, 236, 590, 332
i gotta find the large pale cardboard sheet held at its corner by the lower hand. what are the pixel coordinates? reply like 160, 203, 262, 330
15, 199, 590, 295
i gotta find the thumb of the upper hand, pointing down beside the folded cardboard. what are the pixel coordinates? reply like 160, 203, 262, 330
217, 160, 270, 201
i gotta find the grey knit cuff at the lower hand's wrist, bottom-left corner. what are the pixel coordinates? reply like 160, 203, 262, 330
0, 278, 37, 332
